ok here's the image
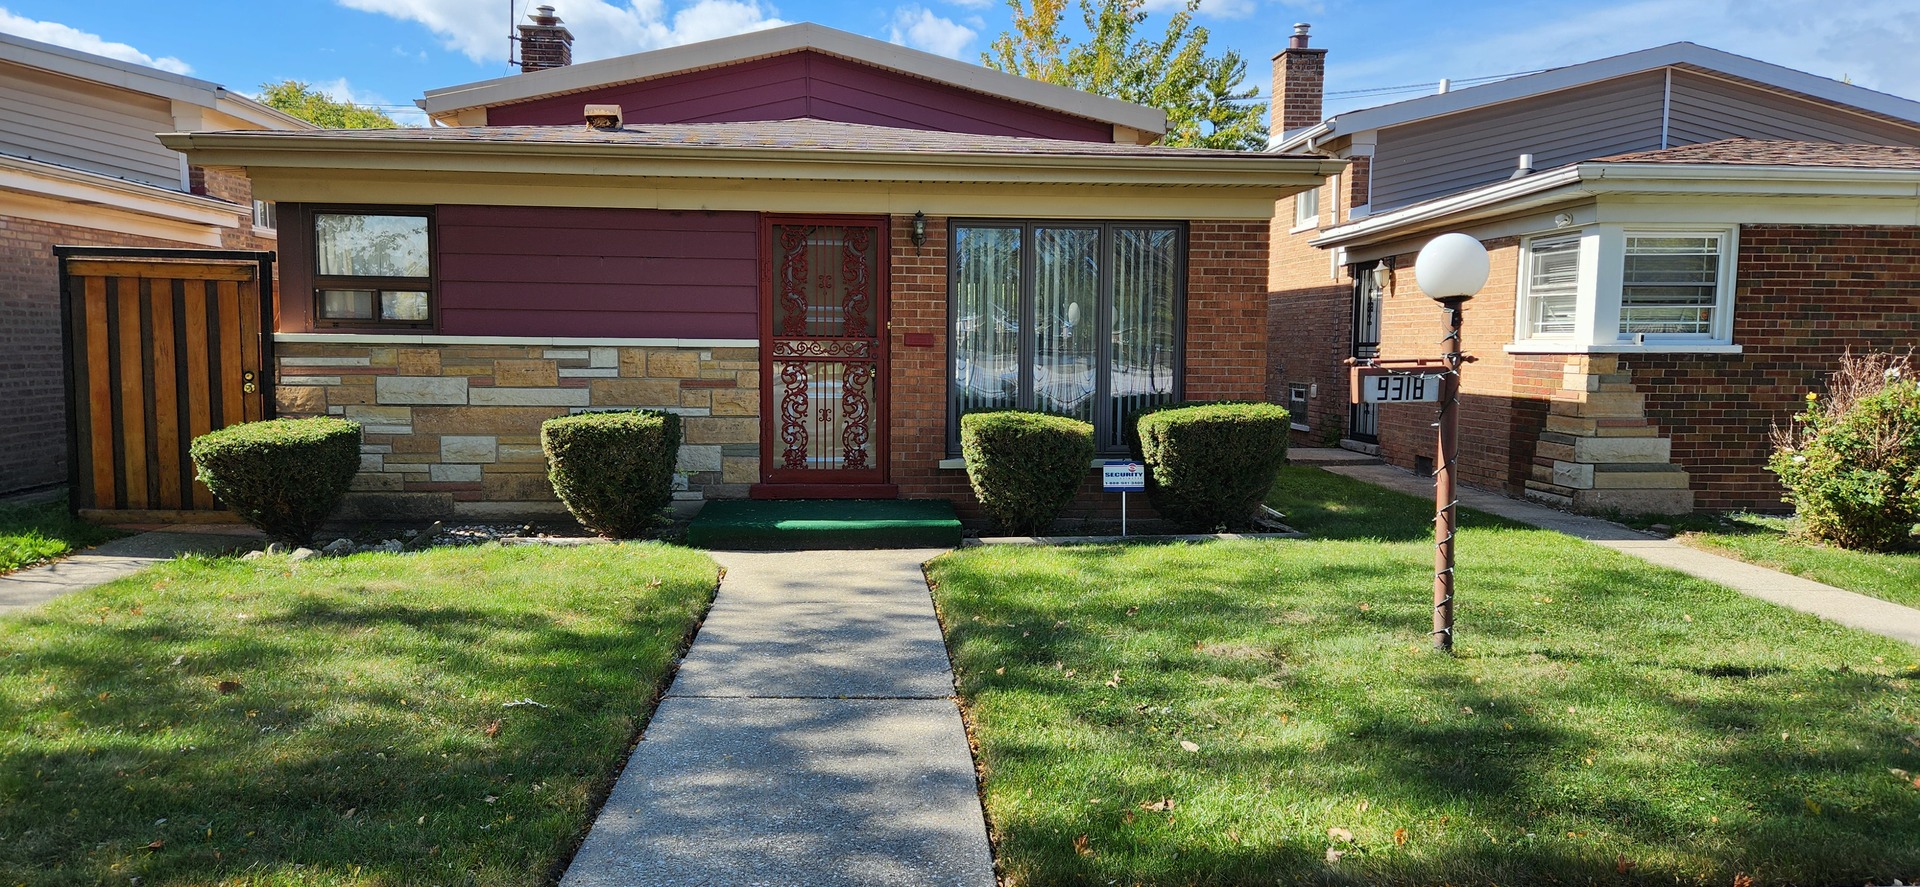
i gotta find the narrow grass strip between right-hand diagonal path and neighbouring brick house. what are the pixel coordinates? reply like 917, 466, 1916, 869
1674, 515, 1920, 607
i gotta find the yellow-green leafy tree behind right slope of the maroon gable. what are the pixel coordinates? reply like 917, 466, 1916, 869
981, 0, 1267, 150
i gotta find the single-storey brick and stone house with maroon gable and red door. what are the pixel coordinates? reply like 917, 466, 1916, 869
165, 17, 1344, 515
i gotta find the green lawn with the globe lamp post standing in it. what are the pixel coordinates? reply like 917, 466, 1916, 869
929, 468, 1920, 887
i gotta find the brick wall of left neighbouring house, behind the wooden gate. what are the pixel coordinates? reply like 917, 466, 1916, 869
0, 167, 273, 493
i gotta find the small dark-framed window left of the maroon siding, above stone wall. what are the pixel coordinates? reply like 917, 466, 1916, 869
313, 209, 434, 328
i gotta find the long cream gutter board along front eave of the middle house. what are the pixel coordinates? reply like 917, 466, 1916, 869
159, 132, 1346, 188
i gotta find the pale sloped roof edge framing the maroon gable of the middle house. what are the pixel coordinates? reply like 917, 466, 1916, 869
415, 23, 1167, 136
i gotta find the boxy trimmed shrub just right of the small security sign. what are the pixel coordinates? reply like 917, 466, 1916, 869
1139, 403, 1288, 530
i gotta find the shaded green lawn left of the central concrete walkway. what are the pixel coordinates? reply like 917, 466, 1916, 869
0, 543, 718, 887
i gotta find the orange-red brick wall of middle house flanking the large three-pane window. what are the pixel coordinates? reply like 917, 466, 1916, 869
889, 215, 1267, 516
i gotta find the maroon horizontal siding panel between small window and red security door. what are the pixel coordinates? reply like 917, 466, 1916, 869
436, 205, 760, 338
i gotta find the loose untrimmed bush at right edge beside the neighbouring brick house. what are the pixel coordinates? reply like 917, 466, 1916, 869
1766, 353, 1920, 551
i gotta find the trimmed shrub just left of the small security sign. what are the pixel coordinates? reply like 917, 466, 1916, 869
960, 411, 1092, 536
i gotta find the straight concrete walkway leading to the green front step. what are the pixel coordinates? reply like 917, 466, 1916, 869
561, 551, 995, 887
